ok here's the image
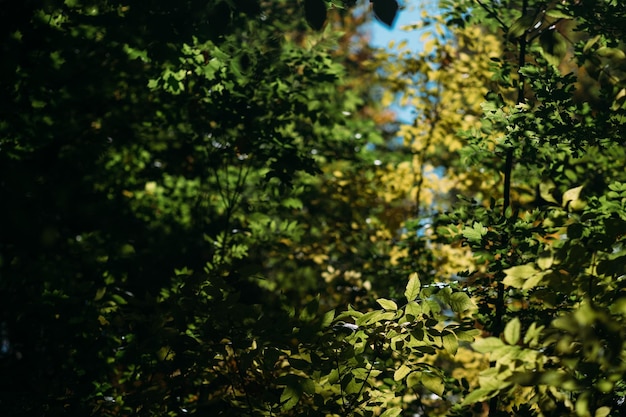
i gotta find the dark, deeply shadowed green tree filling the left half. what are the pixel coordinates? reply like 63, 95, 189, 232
0, 1, 386, 415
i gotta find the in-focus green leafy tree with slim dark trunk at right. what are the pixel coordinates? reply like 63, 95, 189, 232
420, 1, 625, 415
